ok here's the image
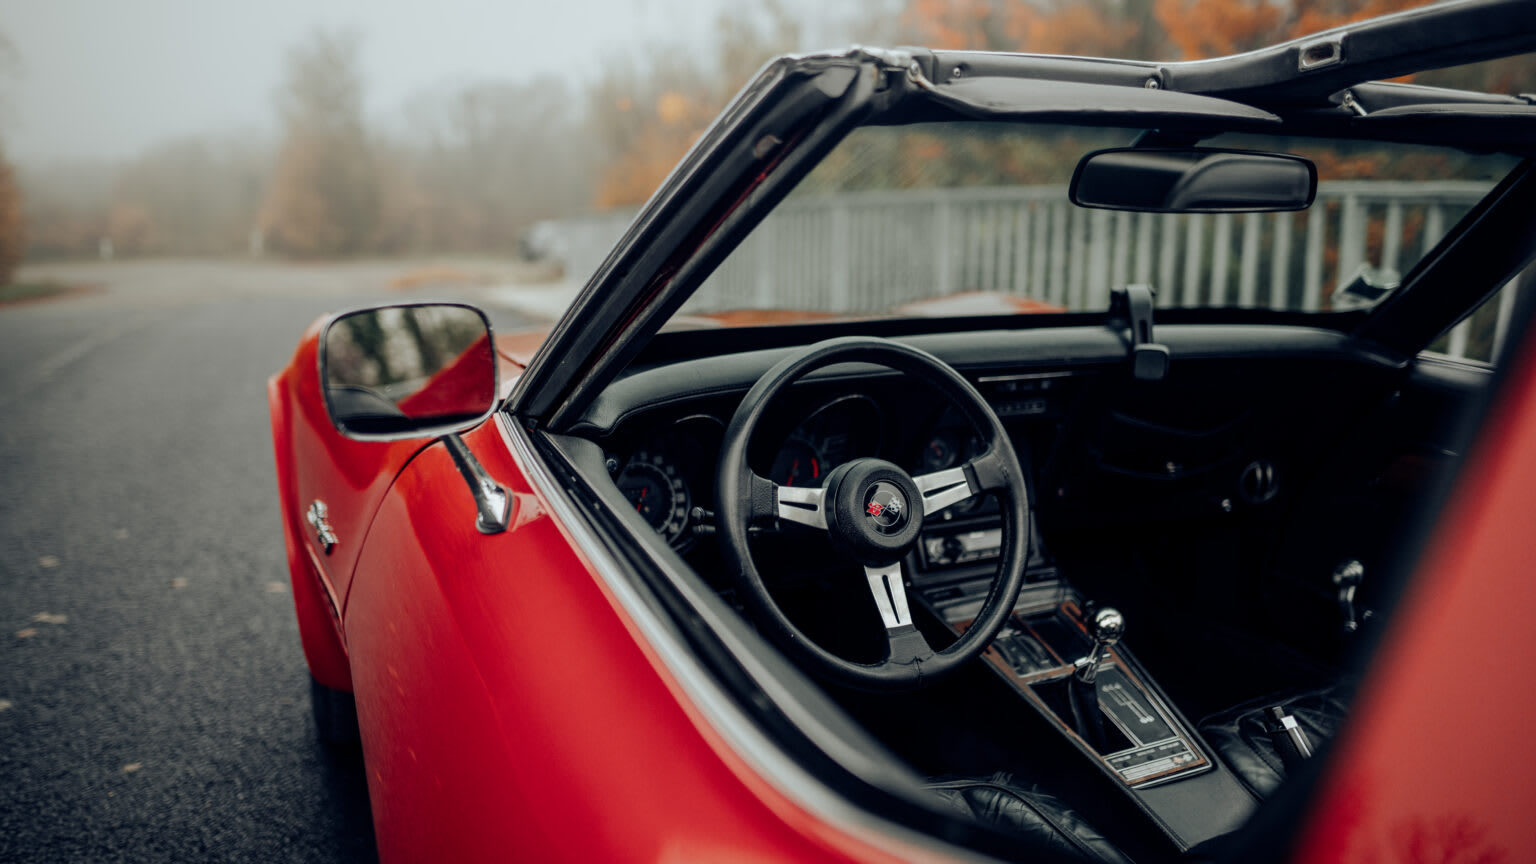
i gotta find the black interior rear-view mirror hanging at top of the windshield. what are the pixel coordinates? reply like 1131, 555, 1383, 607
1069, 148, 1318, 214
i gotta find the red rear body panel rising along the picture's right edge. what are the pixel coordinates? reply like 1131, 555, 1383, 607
1293, 330, 1536, 862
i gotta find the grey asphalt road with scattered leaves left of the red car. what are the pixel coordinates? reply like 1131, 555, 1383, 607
0, 261, 552, 861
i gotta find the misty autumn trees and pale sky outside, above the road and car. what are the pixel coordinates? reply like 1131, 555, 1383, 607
0, 0, 1533, 282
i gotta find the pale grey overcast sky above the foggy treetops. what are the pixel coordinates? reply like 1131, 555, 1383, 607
0, 0, 866, 161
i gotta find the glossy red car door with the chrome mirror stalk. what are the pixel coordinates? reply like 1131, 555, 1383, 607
346, 423, 931, 862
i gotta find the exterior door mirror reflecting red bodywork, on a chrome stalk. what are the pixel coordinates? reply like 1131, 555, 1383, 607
319, 303, 496, 440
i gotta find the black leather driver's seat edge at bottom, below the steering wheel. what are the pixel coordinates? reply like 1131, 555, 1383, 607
928, 773, 1132, 864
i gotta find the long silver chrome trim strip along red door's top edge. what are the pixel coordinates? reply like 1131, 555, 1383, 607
496, 412, 995, 862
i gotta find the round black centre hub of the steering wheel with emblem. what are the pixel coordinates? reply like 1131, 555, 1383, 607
826, 458, 923, 564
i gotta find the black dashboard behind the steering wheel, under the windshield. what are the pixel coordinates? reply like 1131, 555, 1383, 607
578, 326, 1399, 599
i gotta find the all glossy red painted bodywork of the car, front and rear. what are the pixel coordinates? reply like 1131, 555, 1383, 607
269, 305, 1536, 862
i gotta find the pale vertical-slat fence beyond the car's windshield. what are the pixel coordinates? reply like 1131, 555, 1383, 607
554, 180, 1513, 357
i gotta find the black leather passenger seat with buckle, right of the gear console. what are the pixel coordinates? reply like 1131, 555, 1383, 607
1200, 686, 1349, 799
